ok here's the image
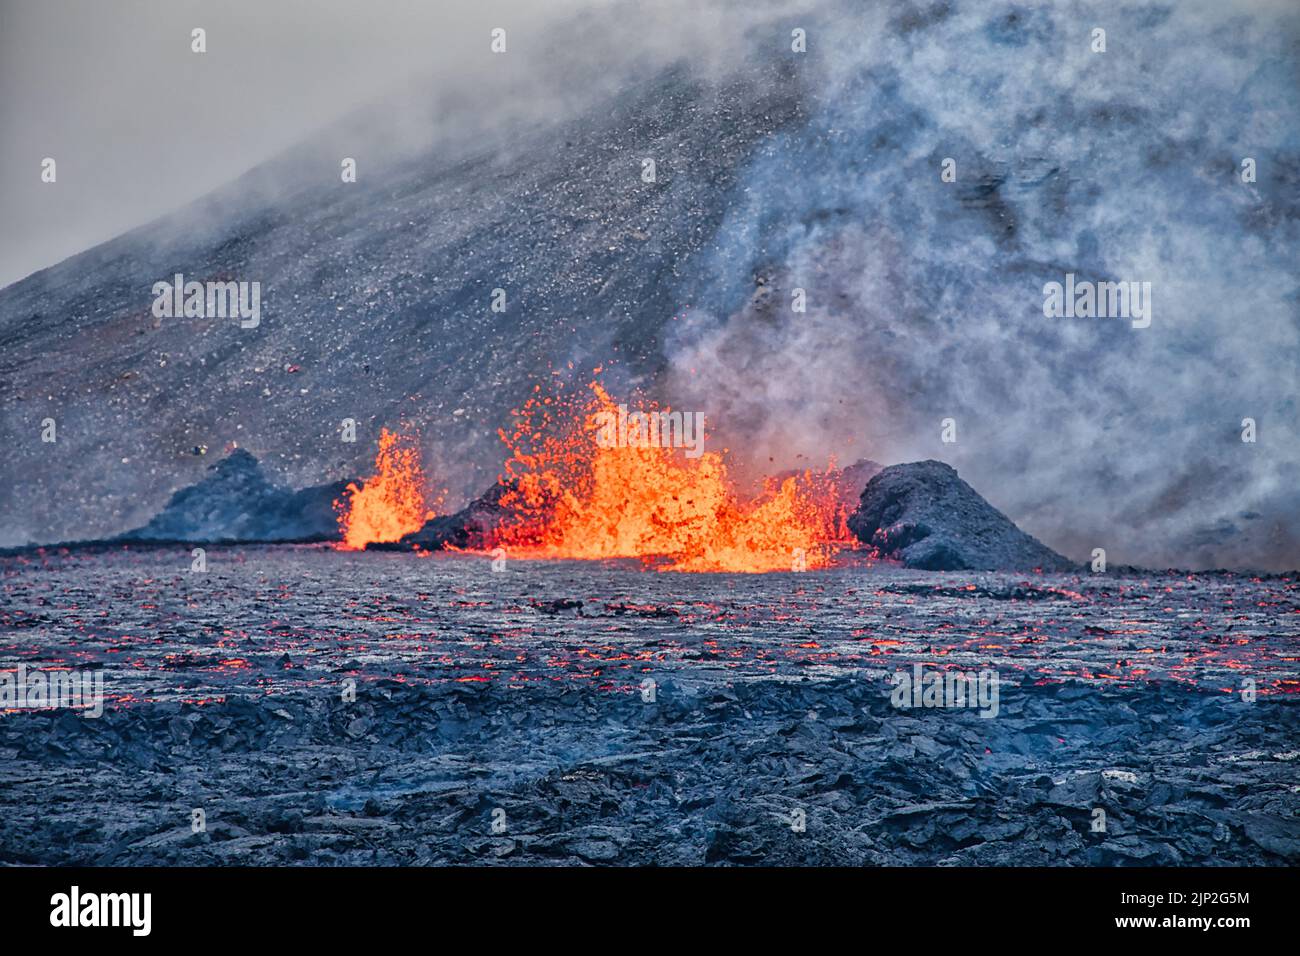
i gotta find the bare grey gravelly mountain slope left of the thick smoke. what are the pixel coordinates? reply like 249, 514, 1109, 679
0, 66, 801, 546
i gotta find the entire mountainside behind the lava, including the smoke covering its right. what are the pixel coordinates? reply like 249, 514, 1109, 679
0, 0, 1300, 570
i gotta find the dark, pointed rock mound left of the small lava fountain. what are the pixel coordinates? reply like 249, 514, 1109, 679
117, 449, 347, 542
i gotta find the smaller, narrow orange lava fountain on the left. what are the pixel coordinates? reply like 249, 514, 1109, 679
334, 428, 437, 550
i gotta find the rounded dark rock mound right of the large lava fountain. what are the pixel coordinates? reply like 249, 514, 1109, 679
849, 460, 1075, 571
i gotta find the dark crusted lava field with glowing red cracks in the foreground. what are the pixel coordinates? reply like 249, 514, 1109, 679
0, 546, 1300, 865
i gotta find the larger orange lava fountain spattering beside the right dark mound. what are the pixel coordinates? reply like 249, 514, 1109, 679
495, 382, 852, 572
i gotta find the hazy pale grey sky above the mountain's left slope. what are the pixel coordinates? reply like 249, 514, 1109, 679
0, 0, 595, 286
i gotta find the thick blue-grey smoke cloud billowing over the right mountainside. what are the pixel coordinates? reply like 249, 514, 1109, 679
667, 3, 1300, 567
